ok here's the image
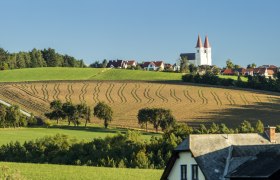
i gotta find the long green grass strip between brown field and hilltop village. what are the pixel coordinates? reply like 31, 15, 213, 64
0, 67, 182, 82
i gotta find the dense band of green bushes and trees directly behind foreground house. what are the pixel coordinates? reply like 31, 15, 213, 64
0, 121, 274, 169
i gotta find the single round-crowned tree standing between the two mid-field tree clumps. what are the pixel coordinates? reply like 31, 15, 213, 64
93, 102, 113, 128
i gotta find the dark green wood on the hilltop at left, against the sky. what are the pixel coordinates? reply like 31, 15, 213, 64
0, 48, 86, 70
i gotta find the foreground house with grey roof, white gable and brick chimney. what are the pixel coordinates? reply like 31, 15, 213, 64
161, 127, 280, 180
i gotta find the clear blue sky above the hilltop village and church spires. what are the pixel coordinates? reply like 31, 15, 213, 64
0, 0, 280, 67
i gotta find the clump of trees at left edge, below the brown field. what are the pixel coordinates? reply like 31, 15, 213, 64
0, 104, 41, 128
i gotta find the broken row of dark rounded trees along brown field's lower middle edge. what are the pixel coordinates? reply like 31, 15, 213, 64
45, 100, 175, 132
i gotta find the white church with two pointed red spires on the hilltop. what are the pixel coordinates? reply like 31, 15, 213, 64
180, 35, 212, 66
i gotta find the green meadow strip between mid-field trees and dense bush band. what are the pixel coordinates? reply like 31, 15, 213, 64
0, 126, 158, 145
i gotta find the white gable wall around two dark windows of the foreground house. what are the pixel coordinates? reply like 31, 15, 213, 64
168, 152, 205, 180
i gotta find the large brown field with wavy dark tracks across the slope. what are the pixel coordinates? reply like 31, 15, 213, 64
0, 80, 280, 128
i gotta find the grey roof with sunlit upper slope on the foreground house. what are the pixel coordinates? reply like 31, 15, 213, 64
162, 133, 280, 179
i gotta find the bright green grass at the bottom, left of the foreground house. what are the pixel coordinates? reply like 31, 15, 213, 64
0, 162, 163, 180
